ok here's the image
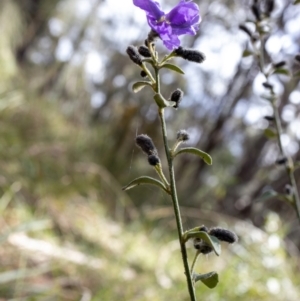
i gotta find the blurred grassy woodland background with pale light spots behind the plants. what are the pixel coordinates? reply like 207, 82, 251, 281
0, 0, 300, 301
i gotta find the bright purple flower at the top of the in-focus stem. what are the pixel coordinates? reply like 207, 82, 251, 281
133, 0, 201, 50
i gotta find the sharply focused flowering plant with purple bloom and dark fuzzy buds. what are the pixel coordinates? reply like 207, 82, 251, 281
123, 0, 237, 301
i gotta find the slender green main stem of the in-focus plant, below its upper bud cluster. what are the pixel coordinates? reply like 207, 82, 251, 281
157, 107, 196, 301
